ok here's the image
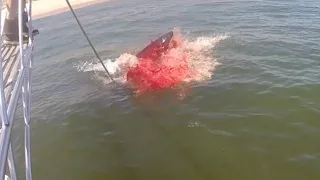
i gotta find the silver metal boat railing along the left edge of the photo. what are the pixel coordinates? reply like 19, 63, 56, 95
0, 0, 34, 180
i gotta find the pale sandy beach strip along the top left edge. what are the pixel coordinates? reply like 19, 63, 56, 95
32, 0, 110, 20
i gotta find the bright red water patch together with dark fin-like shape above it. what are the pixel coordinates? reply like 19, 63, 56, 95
127, 31, 190, 94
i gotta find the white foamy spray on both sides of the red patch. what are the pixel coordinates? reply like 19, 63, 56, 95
76, 28, 229, 90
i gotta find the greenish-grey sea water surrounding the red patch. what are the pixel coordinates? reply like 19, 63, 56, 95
13, 0, 320, 180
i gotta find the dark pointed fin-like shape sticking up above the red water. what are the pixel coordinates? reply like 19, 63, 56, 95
136, 31, 173, 60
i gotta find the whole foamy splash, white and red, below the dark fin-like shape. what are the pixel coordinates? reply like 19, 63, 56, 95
78, 29, 228, 93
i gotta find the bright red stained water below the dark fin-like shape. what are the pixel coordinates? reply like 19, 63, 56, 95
127, 39, 195, 93
